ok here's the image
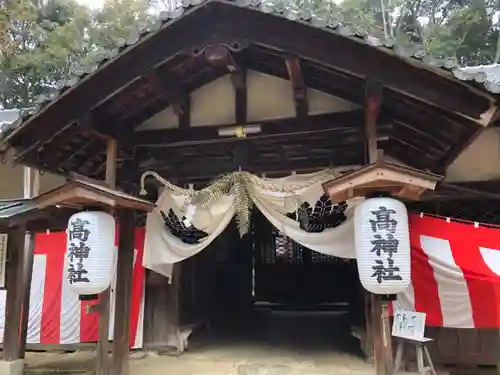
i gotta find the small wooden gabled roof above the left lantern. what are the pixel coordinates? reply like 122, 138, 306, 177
33, 179, 156, 212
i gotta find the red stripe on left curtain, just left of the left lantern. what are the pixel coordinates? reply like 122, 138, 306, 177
35, 232, 66, 344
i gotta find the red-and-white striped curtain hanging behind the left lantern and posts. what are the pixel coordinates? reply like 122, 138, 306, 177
0, 228, 145, 348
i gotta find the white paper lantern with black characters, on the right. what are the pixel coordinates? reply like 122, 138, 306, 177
354, 198, 411, 294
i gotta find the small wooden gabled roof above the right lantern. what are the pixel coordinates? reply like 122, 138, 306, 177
323, 152, 443, 201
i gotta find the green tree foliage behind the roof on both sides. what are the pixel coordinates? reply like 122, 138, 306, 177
0, 0, 500, 108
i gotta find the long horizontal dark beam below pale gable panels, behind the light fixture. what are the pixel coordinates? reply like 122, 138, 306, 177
134, 110, 372, 148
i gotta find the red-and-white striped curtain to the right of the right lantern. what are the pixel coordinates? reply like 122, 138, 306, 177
396, 215, 500, 328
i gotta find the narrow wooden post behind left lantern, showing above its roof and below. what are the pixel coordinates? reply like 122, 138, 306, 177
96, 139, 118, 375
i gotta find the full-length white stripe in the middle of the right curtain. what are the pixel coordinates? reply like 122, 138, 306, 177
418, 236, 474, 328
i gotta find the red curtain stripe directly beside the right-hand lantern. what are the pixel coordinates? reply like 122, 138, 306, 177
409, 215, 443, 327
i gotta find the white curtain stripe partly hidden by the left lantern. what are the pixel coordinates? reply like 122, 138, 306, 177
60, 258, 81, 344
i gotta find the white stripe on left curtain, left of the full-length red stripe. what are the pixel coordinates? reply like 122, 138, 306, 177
26, 254, 47, 344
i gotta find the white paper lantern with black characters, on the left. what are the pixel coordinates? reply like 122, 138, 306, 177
65, 211, 117, 295
